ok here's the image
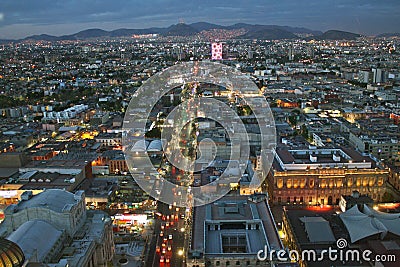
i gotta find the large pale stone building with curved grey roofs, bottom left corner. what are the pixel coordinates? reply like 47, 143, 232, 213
0, 189, 114, 267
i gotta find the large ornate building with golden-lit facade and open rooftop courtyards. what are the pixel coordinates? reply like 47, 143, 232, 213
267, 146, 389, 205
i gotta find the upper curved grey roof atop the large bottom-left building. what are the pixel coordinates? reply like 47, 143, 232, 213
18, 189, 77, 213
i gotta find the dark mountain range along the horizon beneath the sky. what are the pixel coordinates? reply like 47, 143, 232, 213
0, 22, 370, 43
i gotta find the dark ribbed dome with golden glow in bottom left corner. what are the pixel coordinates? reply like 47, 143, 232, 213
0, 238, 25, 267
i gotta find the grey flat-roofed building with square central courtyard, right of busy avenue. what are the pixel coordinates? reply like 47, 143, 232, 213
192, 195, 283, 257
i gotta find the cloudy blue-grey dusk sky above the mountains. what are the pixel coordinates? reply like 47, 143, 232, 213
0, 0, 400, 39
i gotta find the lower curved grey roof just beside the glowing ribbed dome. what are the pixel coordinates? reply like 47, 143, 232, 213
8, 220, 63, 262
